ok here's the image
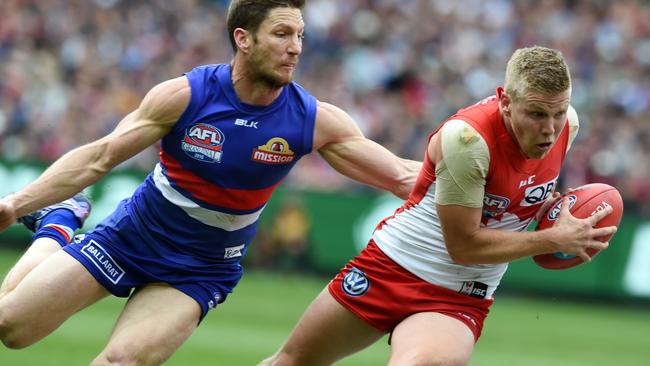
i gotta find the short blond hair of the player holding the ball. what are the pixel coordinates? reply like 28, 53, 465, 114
504, 46, 571, 100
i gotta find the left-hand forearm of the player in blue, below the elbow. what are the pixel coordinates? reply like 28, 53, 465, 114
8, 140, 113, 217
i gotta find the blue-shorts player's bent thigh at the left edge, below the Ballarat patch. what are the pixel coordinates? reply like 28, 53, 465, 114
0, 250, 109, 346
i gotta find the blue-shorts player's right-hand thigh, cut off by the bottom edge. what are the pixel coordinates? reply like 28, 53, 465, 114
93, 284, 201, 365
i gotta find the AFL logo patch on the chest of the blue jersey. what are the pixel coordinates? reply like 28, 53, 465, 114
181, 123, 226, 163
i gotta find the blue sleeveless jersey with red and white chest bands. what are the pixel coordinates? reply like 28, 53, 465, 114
103, 65, 316, 268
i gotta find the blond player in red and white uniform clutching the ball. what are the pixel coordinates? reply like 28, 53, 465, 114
262, 46, 616, 366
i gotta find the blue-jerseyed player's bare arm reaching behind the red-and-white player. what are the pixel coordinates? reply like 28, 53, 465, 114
314, 102, 422, 198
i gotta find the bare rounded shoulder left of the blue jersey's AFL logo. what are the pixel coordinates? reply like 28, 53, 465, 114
138, 76, 192, 123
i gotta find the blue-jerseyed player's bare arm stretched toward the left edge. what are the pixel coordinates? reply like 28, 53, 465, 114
0, 76, 190, 230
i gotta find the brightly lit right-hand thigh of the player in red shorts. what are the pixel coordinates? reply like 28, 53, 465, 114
389, 313, 474, 366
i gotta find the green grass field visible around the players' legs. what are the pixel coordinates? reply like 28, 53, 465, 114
0, 251, 650, 366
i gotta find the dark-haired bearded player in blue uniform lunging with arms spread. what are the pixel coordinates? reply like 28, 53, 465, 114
0, 0, 421, 365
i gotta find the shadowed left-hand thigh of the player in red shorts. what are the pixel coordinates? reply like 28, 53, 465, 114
275, 288, 384, 366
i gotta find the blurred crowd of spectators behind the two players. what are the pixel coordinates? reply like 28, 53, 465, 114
0, 0, 650, 216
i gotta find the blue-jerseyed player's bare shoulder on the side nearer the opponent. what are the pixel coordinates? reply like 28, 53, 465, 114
314, 101, 363, 149
